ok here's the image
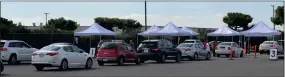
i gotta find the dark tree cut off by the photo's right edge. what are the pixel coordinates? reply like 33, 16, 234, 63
270, 6, 284, 26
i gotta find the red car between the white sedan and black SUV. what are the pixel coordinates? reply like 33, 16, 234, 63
96, 42, 141, 66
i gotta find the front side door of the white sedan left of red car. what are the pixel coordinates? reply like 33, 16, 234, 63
71, 46, 86, 65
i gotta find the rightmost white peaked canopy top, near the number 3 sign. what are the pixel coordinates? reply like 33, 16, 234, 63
240, 21, 281, 37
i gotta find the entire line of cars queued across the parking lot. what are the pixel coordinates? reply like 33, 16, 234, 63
0, 39, 284, 72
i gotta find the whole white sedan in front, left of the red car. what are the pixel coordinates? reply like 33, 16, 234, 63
32, 45, 93, 71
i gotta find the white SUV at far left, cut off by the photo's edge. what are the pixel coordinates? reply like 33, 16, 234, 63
1, 40, 38, 64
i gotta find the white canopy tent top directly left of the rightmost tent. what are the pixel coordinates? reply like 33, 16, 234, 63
207, 25, 240, 36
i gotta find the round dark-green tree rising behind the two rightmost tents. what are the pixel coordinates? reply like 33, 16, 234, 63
223, 12, 253, 31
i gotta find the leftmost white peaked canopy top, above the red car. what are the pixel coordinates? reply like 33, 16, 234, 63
74, 23, 116, 36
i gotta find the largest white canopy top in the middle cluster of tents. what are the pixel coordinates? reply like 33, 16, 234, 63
150, 22, 190, 36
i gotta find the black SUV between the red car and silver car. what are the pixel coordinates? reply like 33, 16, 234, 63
137, 39, 181, 63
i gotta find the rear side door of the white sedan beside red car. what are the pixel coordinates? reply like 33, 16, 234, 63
63, 46, 78, 66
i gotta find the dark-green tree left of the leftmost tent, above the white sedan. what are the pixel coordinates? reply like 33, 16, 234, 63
44, 17, 79, 31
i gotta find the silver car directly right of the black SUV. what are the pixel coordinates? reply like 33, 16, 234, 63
177, 43, 211, 60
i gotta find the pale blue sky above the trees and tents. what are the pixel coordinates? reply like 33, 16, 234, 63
1, 2, 283, 29
